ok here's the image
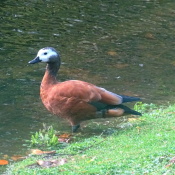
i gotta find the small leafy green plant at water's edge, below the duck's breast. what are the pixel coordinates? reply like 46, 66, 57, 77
31, 124, 60, 147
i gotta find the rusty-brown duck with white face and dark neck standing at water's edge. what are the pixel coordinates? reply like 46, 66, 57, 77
29, 47, 142, 133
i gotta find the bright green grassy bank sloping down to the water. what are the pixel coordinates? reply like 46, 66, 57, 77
6, 104, 175, 175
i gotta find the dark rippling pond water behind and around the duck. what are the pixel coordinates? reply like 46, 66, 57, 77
0, 0, 175, 161
